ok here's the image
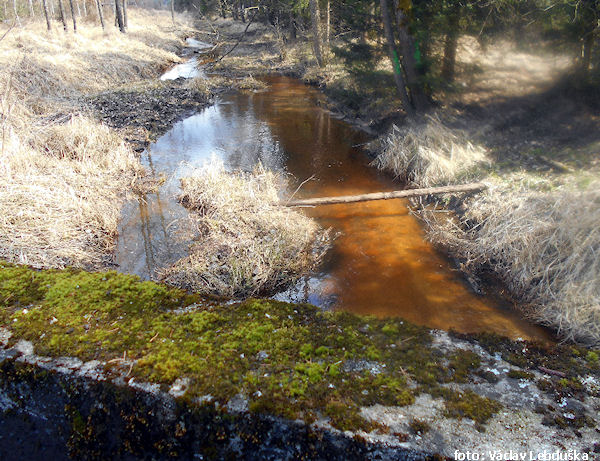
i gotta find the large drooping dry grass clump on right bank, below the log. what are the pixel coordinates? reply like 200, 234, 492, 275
424, 178, 600, 343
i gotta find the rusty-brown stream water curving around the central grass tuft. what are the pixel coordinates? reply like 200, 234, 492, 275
117, 77, 548, 339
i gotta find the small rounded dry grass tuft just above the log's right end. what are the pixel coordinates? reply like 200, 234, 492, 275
373, 116, 488, 187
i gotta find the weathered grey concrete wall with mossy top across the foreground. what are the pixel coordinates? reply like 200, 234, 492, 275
0, 263, 600, 456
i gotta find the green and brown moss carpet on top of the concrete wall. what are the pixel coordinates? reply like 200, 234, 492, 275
0, 263, 506, 430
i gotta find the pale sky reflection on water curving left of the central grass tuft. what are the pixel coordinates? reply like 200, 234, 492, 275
117, 98, 284, 279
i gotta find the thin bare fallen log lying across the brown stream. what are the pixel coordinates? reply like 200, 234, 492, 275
281, 182, 487, 206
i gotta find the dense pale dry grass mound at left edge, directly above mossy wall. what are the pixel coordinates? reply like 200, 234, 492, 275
0, 116, 139, 267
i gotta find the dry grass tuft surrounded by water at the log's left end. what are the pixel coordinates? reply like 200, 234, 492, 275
162, 161, 329, 297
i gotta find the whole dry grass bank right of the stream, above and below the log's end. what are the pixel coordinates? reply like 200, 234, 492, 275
375, 113, 600, 344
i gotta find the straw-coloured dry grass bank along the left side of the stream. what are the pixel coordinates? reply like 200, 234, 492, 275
0, 9, 195, 267
